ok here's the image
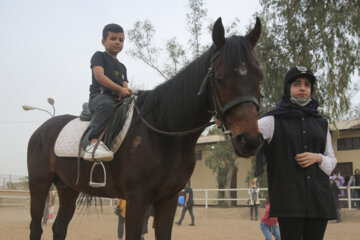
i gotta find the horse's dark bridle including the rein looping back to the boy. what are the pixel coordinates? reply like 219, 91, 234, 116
134, 50, 259, 136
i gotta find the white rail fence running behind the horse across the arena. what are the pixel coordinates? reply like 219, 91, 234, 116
0, 187, 360, 209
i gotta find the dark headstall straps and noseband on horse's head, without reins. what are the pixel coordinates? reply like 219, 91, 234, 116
198, 51, 259, 133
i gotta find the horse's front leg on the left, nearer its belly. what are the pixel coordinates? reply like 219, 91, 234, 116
125, 196, 149, 240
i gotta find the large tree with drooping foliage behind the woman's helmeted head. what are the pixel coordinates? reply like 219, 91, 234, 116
256, 0, 360, 121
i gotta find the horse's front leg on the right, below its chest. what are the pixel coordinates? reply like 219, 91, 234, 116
154, 195, 177, 240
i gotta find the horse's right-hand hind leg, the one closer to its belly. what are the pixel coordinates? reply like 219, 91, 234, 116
52, 187, 79, 240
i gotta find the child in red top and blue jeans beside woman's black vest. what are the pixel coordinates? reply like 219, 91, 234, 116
260, 196, 281, 240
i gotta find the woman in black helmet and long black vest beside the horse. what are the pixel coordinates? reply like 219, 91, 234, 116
257, 67, 337, 240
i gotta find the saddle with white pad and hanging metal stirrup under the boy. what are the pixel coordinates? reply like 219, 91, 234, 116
54, 97, 135, 187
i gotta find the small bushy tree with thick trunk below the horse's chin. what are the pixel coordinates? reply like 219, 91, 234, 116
205, 126, 238, 206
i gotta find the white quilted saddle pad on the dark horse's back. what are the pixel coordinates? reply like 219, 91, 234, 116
54, 100, 135, 157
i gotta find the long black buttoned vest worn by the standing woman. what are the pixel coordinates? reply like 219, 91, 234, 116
267, 116, 336, 219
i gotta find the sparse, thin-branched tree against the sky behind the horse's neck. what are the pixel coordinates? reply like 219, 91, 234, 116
127, 0, 239, 80
